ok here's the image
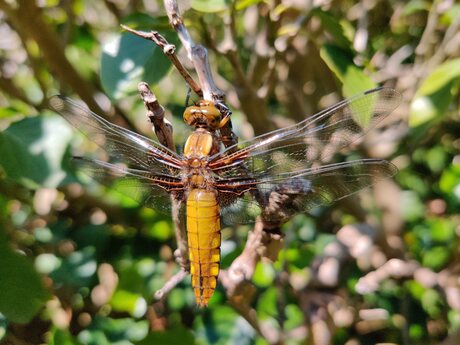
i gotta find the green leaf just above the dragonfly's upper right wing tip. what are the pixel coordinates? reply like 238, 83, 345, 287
320, 44, 376, 97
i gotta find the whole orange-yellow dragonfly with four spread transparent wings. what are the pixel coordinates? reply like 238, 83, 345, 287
50, 88, 401, 306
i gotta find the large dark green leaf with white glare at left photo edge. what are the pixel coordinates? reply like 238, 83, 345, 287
0, 116, 72, 188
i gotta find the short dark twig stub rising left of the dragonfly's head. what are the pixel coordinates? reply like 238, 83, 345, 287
138, 82, 175, 151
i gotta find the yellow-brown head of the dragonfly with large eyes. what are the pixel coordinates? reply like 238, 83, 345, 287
184, 100, 229, 130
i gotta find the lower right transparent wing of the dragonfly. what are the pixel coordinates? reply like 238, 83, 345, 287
219, 159, 398, 225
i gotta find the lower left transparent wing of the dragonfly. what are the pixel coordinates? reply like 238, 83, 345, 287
73, 157, 184, 215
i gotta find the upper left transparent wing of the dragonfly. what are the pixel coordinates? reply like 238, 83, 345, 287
49, 96, 185, 176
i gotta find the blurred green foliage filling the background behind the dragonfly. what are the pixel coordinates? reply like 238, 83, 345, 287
0, 0, 460, 345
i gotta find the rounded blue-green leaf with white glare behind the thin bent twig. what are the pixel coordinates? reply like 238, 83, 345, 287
101, 17, 179, 99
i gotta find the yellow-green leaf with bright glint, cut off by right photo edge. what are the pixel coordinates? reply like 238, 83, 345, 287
409, 58, 460, 127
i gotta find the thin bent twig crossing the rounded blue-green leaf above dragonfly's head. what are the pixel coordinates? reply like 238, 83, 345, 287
120, 24, 203, 97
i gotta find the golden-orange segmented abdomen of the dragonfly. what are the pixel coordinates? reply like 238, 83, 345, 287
187, 188, 221, 306
